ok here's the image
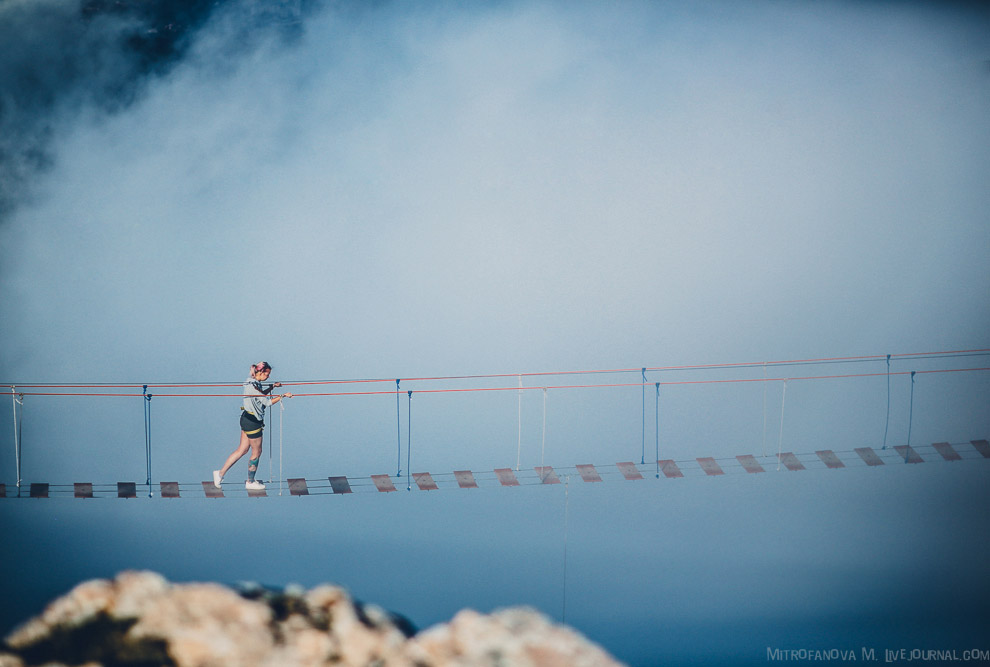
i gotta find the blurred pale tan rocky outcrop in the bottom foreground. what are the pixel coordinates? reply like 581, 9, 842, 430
0, 572, 618, 667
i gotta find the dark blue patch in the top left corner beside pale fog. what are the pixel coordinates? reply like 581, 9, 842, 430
0, 0, 252, 221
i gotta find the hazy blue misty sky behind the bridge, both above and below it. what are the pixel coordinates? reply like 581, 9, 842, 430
0, 0, 990, 664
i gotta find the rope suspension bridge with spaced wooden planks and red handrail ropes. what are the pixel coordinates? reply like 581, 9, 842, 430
0, 349, 990, 499
